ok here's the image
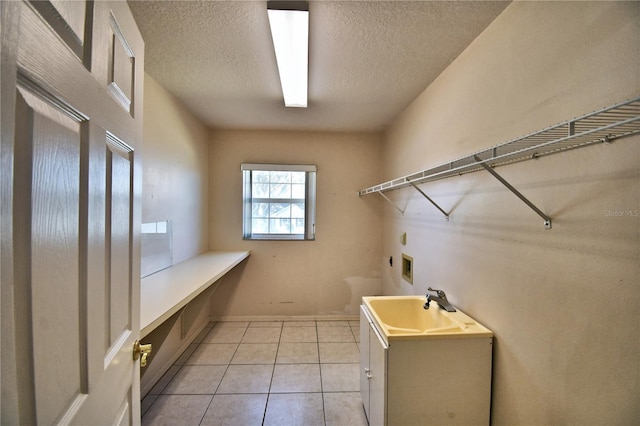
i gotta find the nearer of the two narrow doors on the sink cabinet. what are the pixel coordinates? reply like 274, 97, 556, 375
369, 324, 387, 426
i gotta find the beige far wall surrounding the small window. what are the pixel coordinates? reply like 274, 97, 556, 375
209, 131, 382, 317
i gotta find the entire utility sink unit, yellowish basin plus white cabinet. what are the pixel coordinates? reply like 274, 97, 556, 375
360, 296, 493, 426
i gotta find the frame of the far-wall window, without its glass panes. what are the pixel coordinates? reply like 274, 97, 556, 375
240, 163, 317, 241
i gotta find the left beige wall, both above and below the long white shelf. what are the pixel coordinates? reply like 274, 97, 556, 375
140, 75, 210, 396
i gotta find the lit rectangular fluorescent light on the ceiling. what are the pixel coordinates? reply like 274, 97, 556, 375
267, 1, 309, 108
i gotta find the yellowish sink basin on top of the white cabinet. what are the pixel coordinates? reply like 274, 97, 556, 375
362, 296, 493, 340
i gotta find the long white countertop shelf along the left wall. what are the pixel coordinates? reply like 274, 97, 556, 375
140, 251, 251, 337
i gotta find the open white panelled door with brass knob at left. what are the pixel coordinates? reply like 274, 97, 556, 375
1, 0, 144, 425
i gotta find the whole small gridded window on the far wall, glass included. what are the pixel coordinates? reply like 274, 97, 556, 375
242, 163, 316, 240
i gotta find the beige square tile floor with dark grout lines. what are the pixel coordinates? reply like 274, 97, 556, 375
142, 321, 367, 426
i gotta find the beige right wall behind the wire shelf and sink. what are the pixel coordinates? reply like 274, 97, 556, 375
382, 2, 640, 425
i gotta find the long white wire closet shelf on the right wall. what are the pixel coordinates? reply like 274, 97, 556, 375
358, 97, 640, 198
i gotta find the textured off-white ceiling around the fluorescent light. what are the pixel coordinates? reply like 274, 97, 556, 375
129, 0, 508, 131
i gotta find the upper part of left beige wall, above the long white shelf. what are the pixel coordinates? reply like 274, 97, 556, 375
142, 75, 209, 263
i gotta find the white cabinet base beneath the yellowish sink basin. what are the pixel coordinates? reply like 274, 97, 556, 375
360, 305, 492, 426
